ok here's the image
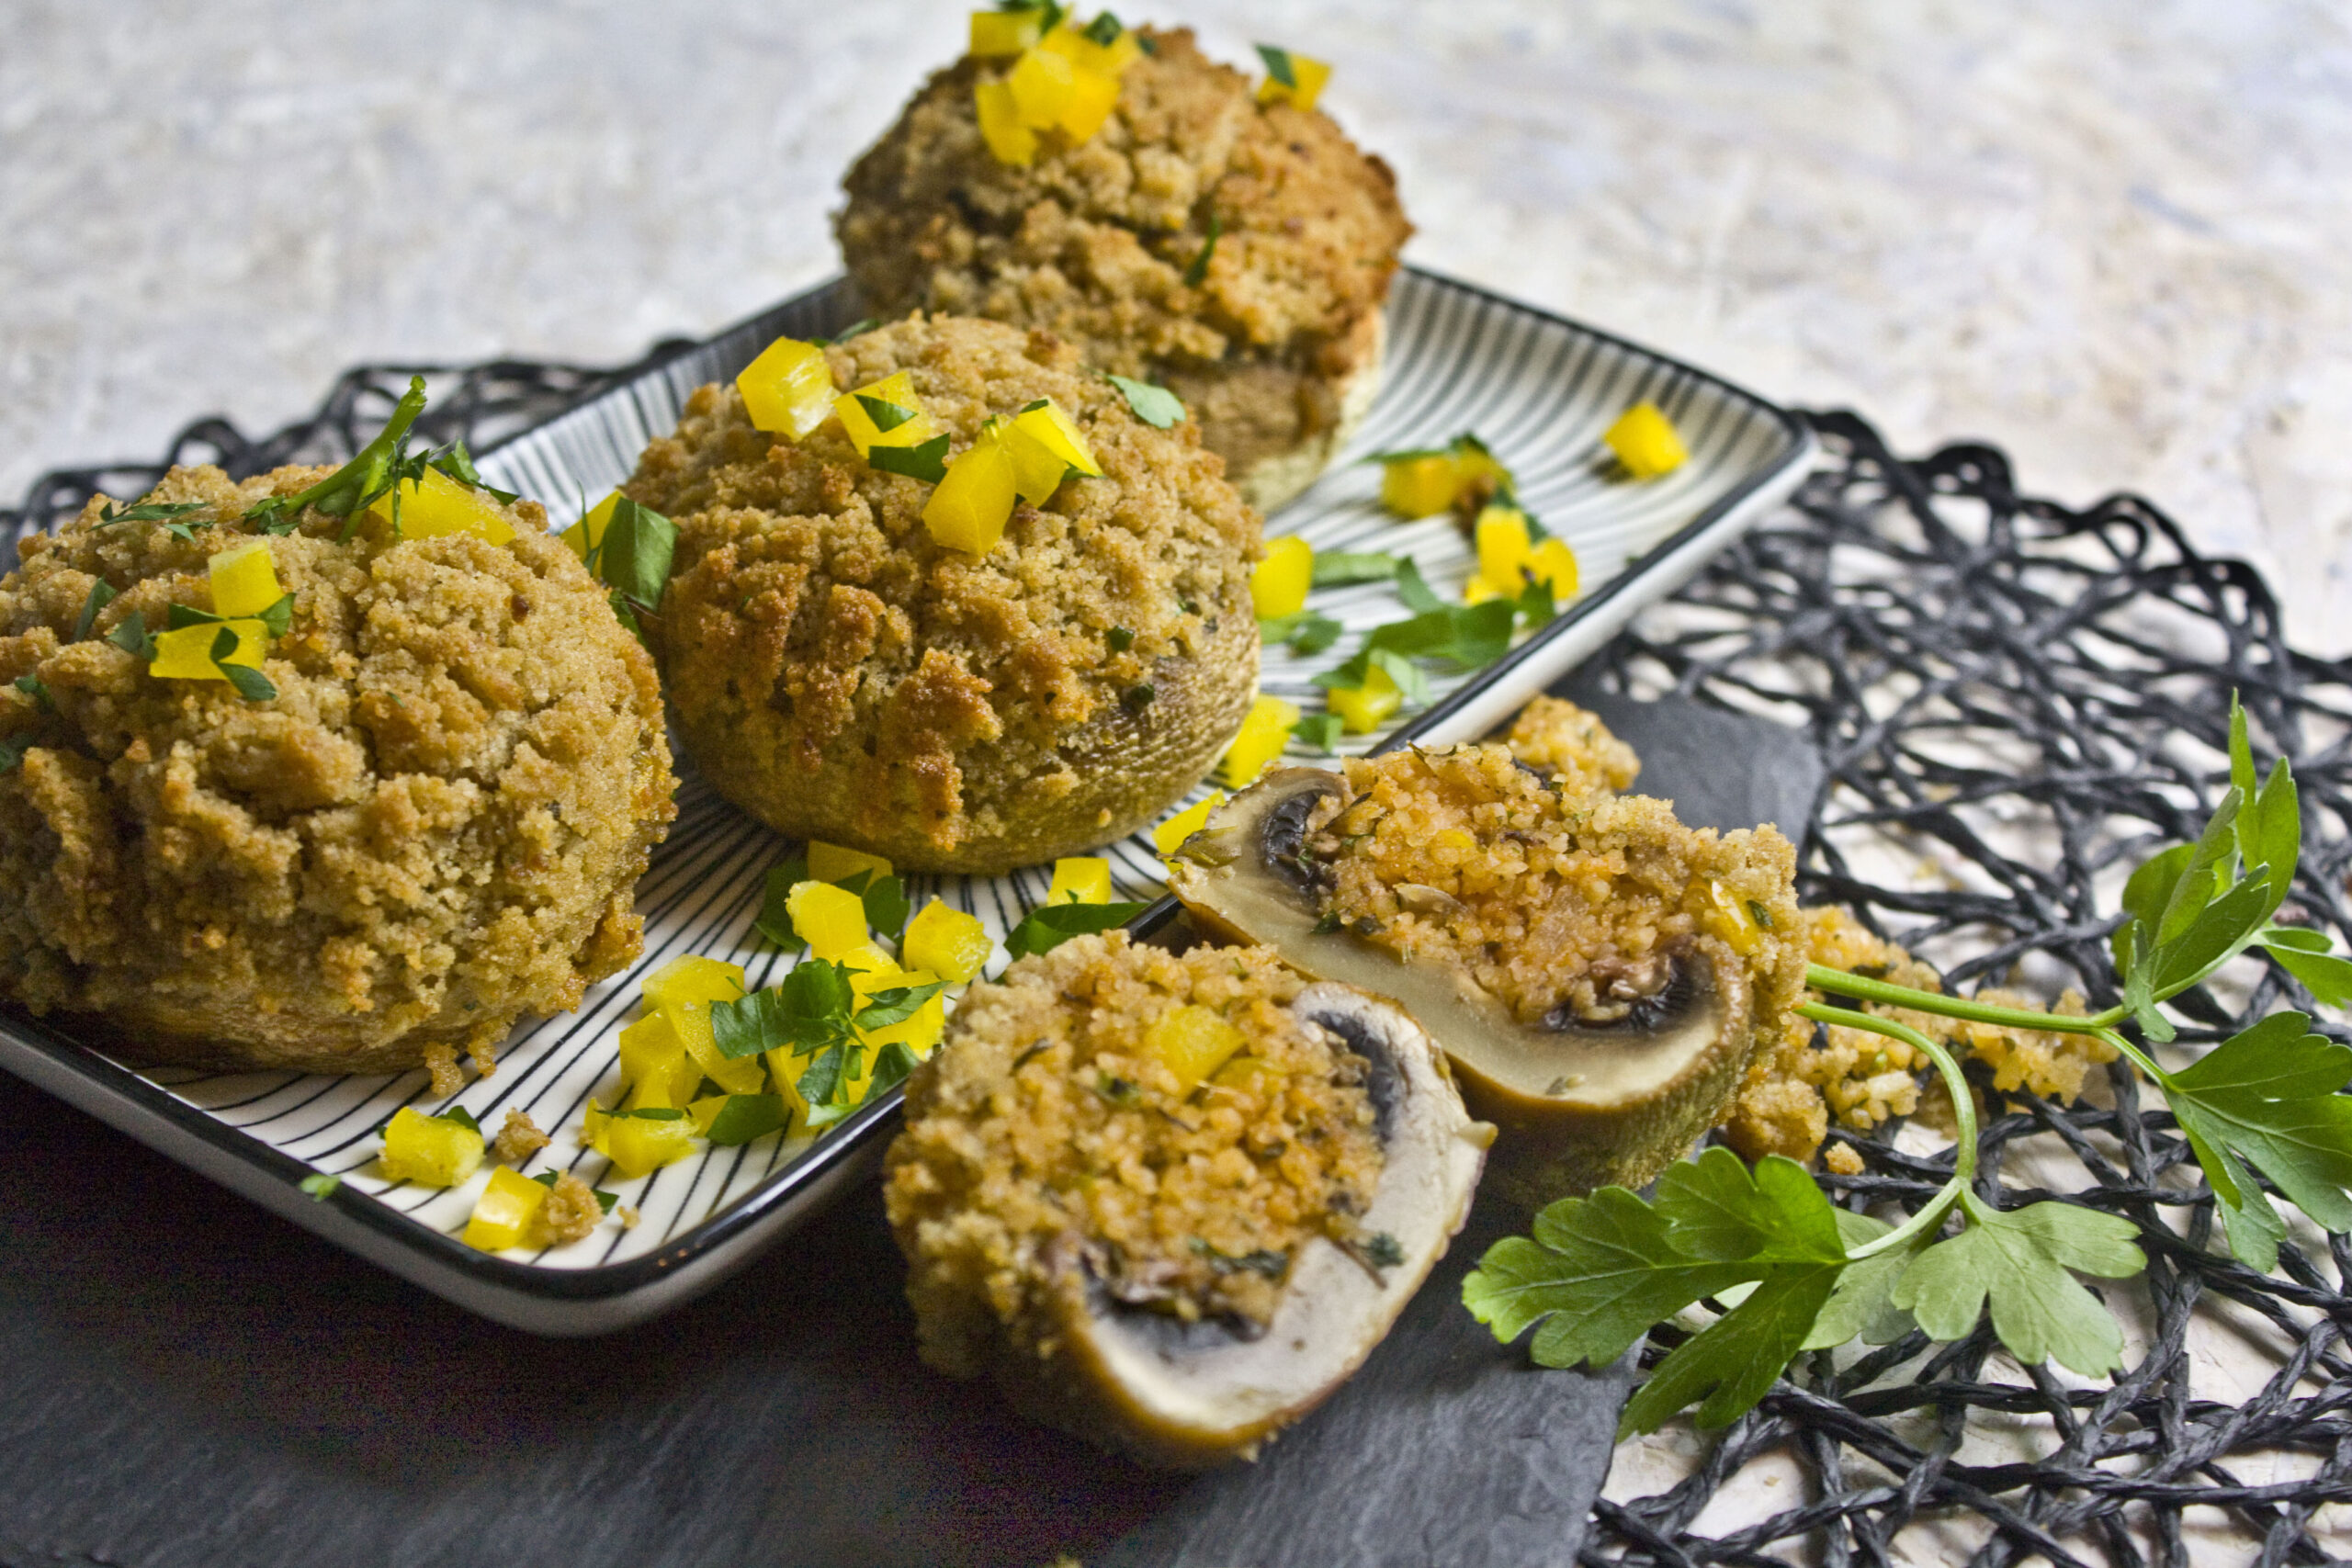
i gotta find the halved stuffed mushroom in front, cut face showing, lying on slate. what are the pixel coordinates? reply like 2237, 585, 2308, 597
887, 933, 1494, 1467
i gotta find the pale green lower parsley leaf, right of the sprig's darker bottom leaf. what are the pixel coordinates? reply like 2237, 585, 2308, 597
1889, 1187, 2147, 1378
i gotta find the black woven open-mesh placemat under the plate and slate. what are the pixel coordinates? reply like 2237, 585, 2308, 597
0, 376, 2352, 1568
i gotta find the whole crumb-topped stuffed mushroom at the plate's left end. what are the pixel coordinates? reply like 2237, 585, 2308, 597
0, 468, 675, 1072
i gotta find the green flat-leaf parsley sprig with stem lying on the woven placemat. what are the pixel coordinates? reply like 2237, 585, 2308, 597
1463, 698, 2352, 1437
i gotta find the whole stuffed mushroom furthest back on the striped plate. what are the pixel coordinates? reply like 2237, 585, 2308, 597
837, 28, 1411, 510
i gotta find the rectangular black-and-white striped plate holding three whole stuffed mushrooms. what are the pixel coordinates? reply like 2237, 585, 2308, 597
0, 273, 1811, 1333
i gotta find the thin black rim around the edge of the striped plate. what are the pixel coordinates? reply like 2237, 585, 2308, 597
0, 268, 1811, 1303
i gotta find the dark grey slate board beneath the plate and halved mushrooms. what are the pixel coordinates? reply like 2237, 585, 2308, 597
0, 703, 1820, 1568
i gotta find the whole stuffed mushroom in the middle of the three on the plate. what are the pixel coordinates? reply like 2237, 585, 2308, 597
626, 317, 1261, 872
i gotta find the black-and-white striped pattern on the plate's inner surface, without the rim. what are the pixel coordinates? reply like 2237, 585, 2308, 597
18, 273, 1806, 1328
